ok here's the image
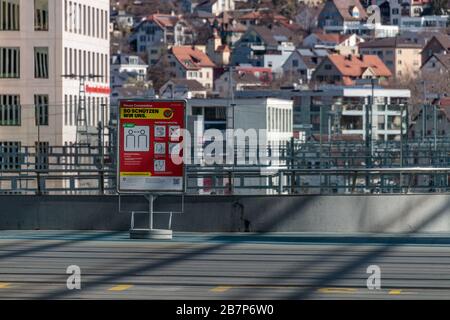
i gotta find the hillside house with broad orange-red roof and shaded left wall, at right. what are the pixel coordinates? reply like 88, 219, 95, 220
312, 54, 392, 85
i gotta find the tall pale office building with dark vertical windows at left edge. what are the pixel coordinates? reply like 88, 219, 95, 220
0, 0, 110, 152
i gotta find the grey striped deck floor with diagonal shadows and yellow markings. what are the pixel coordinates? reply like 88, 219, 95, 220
0, 231, 450, 299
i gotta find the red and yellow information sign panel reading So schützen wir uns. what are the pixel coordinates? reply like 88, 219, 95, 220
118, 100, 186, 193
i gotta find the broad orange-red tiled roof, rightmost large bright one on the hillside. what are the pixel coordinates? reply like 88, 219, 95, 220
328, 54, 392, 78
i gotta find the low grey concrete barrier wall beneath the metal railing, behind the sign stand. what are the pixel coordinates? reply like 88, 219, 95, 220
0, 195, 450, 233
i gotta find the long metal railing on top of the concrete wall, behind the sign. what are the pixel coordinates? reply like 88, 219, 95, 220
0, 138, 450, 195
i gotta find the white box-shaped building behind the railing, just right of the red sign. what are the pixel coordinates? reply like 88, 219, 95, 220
187, 98, 293, 194
